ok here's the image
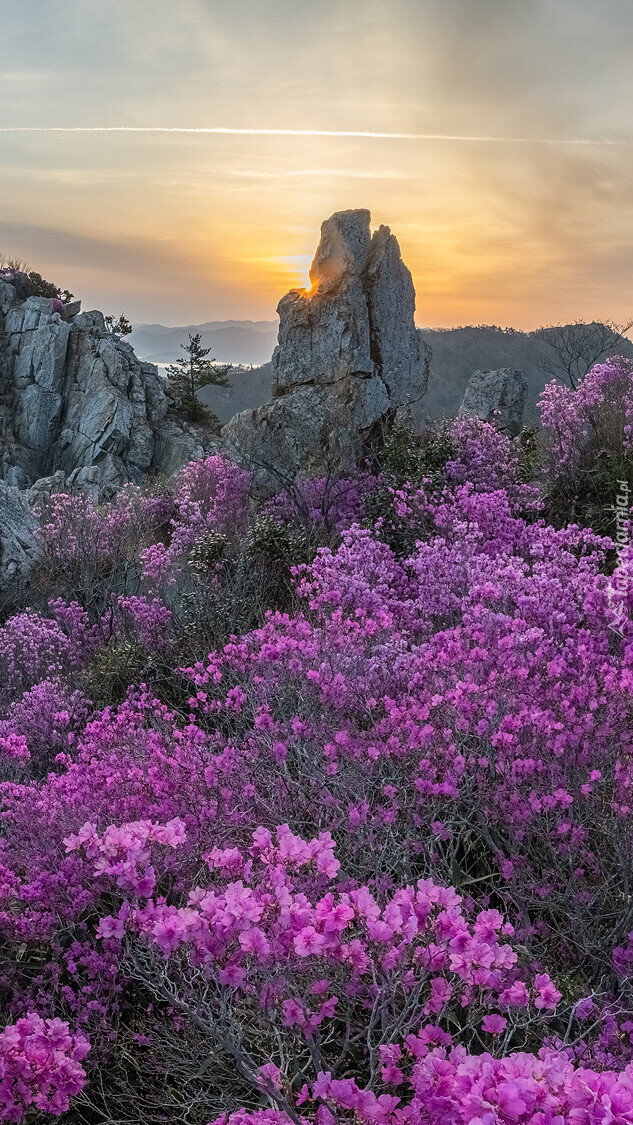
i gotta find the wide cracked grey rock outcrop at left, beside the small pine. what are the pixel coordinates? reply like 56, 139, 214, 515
0, 279, 205, 497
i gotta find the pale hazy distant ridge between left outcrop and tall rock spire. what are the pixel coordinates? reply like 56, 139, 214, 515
128, 321, 278, 366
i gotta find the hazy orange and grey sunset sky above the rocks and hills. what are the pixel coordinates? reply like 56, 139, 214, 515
0, 0, 633, 329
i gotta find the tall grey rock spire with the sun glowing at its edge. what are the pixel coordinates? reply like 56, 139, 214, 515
223, 210, 429, 489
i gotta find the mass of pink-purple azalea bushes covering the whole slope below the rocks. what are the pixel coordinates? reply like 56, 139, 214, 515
0, 378, 633, 1125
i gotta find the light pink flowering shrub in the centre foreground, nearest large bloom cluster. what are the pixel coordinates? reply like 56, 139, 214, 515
83, 820, 561, 1107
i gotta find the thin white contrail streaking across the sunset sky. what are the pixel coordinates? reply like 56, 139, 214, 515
0, 125, 633, 149
